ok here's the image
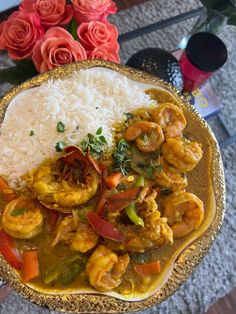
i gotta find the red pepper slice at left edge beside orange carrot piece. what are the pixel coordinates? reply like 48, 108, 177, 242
0, 230, 22, 269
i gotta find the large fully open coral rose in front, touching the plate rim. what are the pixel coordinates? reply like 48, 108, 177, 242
32, 27, 87, 73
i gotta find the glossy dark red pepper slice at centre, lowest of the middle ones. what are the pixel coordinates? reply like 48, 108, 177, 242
86, 212, 124, 242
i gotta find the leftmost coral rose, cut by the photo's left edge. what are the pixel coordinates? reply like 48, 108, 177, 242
0, 11, 44, 60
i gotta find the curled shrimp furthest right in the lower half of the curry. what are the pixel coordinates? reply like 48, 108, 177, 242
162, 191, 204, 238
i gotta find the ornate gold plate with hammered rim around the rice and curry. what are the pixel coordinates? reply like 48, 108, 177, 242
0, 60, 225, 313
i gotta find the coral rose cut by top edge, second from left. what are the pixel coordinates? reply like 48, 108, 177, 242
20, 0, 73, 29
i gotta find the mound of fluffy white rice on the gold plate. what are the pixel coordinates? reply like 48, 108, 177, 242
0, 68, 152, 189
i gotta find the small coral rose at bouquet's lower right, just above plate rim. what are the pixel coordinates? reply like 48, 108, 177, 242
87, 44, 120, 63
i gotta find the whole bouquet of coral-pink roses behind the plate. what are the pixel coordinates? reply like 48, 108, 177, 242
0, 0, 120, 84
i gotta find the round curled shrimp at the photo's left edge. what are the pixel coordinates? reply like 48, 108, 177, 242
2, 196, 44, 239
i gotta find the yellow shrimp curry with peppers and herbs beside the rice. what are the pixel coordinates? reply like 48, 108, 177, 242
0, 91, 204, 294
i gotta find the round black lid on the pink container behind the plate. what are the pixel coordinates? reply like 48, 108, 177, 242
186, 32, 228, 72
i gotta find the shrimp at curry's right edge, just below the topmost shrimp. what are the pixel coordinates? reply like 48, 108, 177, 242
162, 138, 202, 172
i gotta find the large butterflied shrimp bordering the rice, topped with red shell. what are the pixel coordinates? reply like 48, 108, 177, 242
23, 160, 100, 213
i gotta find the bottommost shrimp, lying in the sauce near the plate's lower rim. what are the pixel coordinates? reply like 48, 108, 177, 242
85, 245, 130, 291
